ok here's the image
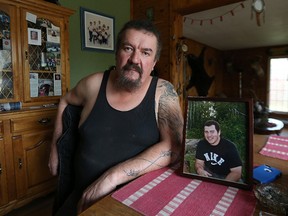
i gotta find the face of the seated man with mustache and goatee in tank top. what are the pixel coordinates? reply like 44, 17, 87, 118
116, 29, 157, 90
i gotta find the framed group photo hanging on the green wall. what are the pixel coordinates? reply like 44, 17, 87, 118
80, 7, 115, 52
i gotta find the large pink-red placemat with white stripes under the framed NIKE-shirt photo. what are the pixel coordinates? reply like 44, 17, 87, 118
112, 168, 256, 216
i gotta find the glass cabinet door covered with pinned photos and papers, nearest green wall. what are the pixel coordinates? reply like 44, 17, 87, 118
24, 11, 65, 102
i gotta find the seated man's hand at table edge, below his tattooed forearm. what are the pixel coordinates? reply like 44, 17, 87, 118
78, 173, 116, 214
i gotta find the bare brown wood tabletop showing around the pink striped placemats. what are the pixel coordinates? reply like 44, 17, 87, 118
80, 134, 288, 216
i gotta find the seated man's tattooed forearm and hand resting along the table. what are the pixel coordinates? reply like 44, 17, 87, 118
79, 142, 178, 212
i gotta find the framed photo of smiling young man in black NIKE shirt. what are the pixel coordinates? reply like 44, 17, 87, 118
180, 97, 253, 190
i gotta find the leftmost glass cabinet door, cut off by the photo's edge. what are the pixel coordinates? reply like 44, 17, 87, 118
0, 5, 18, 103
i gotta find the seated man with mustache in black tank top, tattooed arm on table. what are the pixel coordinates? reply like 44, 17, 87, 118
49, 20, 183, 215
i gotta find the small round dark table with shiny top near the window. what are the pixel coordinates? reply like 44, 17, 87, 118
254, 118, 284, 135
